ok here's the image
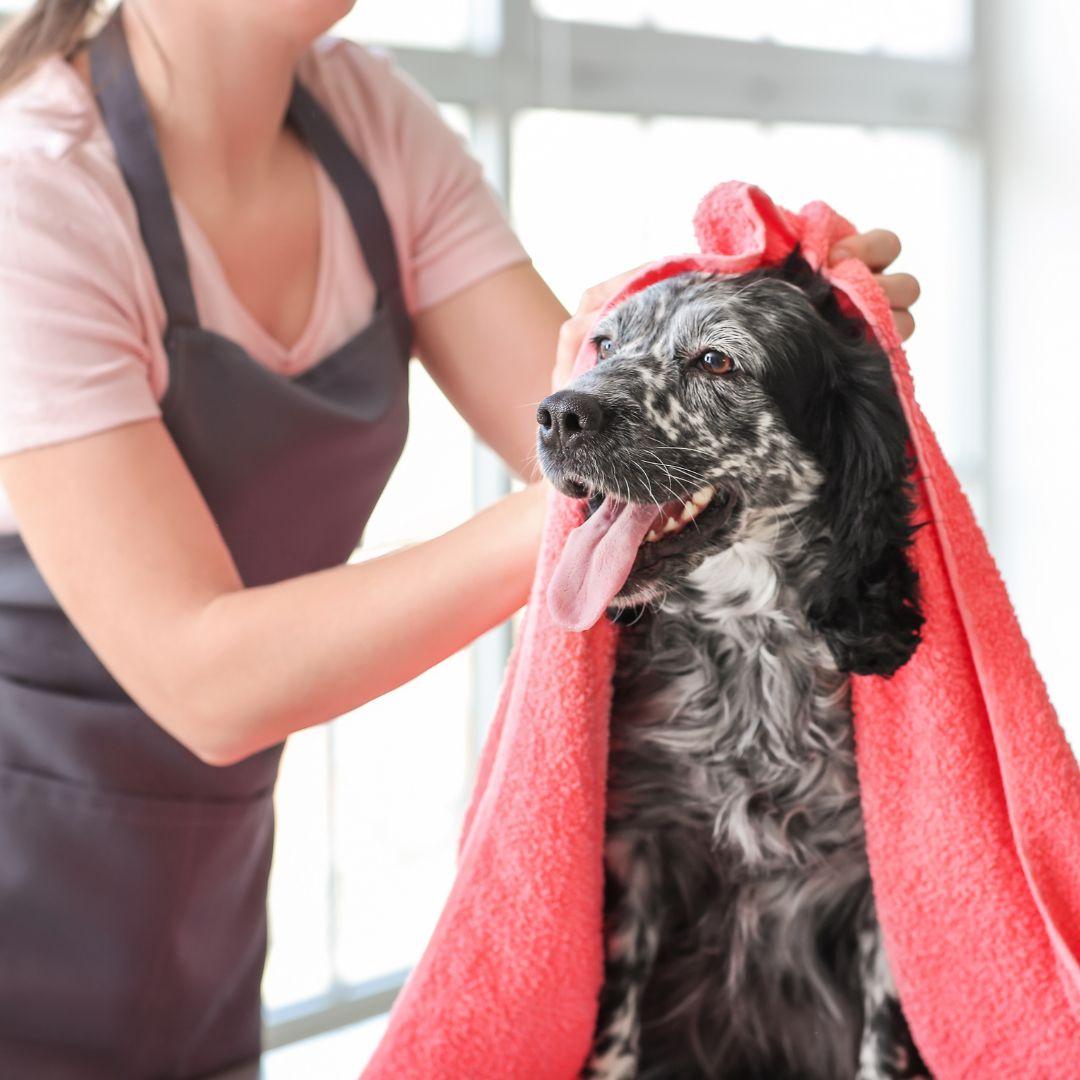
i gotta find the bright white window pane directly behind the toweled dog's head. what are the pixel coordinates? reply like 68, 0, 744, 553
512, 110, 984, 468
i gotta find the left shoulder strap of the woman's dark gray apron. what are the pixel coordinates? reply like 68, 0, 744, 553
90, 5, 199, 326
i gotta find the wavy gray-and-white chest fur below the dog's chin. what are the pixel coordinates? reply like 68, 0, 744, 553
608, 531, 869, 1077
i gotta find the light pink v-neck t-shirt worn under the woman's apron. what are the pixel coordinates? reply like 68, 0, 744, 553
0, 37, 528, 531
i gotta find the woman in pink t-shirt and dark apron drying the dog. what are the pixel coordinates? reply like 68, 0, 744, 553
0, 0, 917, 1077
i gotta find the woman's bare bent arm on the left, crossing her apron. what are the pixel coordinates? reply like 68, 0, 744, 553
0, 416, 550, 765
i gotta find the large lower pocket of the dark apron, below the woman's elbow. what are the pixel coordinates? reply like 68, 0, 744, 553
0, 767, 273, 1078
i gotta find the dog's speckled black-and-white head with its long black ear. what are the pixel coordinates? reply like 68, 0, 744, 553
537, 252, 922, 674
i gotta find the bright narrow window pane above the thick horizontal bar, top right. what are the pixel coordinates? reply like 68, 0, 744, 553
535, 0, 970, 57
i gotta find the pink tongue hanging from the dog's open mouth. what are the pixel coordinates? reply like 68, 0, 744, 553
548, 496, 660, 631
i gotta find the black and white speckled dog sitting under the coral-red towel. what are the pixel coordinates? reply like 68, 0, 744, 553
538, 252, 929, 1080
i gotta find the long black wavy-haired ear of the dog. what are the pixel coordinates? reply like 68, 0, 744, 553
808, 324, 923, 675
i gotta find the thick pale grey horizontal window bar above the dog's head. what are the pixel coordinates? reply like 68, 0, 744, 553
386, 22, 977, 131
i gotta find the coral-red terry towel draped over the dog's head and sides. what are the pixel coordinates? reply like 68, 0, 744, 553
364, 183, 1080, 1080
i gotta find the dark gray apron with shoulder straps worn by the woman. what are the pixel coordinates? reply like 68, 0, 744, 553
0, 12, 410, 1080
